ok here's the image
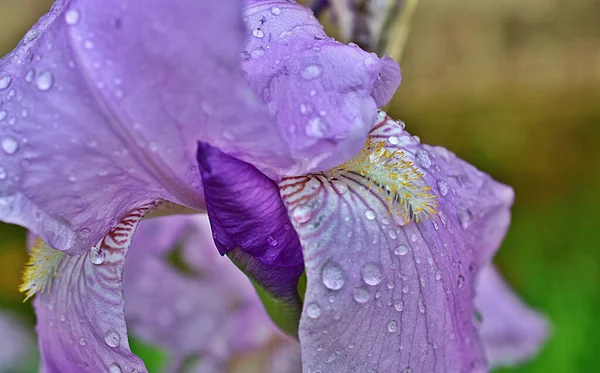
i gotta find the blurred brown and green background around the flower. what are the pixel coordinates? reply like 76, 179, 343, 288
0, 0, 600, 373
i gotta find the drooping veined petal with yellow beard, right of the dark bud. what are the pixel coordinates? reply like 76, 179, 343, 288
280, 113, 512, 373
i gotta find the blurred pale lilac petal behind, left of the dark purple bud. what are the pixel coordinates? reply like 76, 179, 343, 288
124, 215, 280, 358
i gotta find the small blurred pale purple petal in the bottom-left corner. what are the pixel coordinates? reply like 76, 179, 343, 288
0, 312, 32, 372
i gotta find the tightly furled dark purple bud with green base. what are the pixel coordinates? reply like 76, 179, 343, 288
198, 143, 304, 331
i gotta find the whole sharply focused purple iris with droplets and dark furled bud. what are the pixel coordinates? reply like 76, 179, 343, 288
0, 0, 545, 373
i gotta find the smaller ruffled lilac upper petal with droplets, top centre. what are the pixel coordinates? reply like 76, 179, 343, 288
242, 0, 400, 175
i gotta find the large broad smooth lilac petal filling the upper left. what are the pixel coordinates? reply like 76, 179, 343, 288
0, 0, 290, 254
